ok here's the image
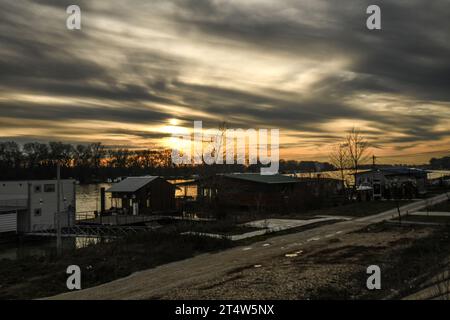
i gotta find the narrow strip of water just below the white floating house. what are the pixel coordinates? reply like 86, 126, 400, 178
0, 237, 105, 260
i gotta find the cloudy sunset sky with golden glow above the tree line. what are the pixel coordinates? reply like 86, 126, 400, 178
0, 0, 450, 163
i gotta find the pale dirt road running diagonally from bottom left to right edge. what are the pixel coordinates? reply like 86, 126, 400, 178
49, 194, 447, 299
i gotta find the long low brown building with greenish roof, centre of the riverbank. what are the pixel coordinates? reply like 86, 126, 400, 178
197, 173, 340, 213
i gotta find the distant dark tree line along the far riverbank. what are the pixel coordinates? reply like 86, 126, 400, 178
0, 141, 334, 183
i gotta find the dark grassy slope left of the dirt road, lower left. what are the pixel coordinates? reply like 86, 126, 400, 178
0, 232, 233, 299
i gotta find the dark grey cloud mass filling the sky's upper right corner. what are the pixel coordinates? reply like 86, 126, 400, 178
171, 0, 450, 101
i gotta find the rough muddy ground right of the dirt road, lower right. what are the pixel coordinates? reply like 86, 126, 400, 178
160, 223, 450, 299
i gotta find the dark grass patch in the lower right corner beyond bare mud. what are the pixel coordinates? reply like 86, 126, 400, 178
309, 222, 450, 300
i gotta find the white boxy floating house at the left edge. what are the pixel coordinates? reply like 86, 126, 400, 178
0, 180, 76, 234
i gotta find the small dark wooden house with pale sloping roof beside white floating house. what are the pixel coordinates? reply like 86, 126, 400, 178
106, 176, 176, 215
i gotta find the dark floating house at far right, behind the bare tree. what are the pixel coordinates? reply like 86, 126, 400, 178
355, 167, 428, 199
